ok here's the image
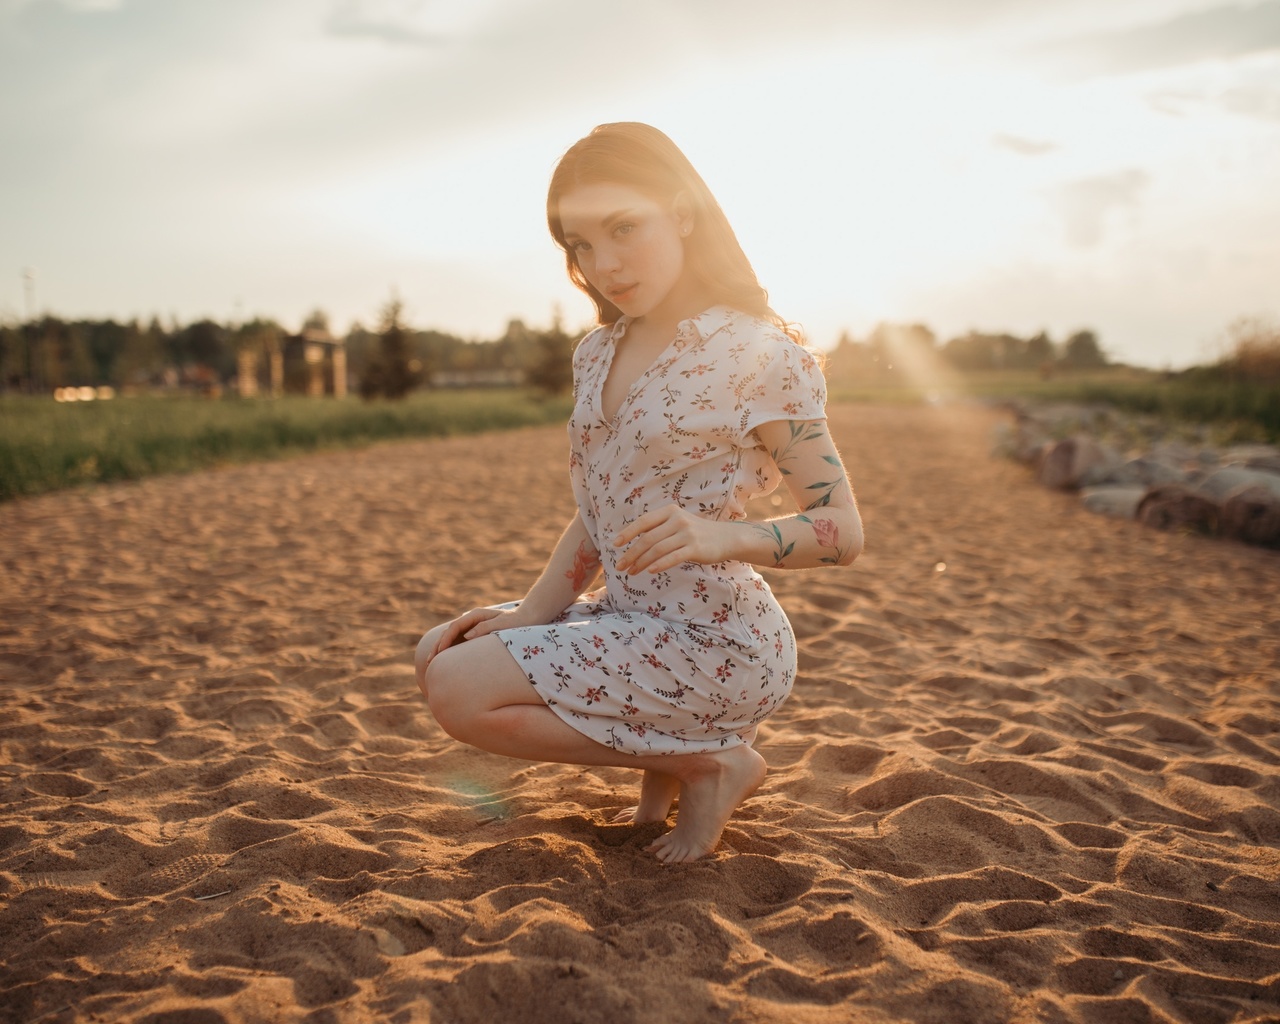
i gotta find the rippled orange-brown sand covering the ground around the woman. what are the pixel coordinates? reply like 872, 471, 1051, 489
0, 406, 1280, 1024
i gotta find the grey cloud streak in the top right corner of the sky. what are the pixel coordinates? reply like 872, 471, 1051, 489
1036, 0, 1280, 78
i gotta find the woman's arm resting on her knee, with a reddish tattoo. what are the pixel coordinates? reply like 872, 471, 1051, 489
419, 515, 600, 658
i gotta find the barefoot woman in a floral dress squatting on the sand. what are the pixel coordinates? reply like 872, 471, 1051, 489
416, 123, 863, 864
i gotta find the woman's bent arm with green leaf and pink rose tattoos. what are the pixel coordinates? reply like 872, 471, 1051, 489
614, 420, 863, 575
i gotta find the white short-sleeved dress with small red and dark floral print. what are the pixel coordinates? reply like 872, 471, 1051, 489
497, 306, 827, 754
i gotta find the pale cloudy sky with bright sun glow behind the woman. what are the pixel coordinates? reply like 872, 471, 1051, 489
0, 0, 1280, 367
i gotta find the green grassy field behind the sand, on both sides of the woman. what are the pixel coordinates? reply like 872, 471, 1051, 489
0, 369, 1280, 500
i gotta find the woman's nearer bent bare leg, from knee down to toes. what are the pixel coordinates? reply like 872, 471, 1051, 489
420, 634, 765, 864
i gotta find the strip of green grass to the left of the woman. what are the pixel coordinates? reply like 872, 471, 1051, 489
0, 389, 571, 500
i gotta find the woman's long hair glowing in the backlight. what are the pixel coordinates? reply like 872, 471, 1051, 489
547, 122, 801, 342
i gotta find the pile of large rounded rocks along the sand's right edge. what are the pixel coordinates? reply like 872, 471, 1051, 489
997, 406, 1280, 548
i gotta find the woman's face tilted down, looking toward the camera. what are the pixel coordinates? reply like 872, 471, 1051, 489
559, 183, 692, 319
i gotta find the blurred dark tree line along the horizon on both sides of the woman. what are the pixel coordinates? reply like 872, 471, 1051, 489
0, 300, 1108, 398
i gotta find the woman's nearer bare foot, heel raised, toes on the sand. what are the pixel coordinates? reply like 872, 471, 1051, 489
645, 744, 765, 864
